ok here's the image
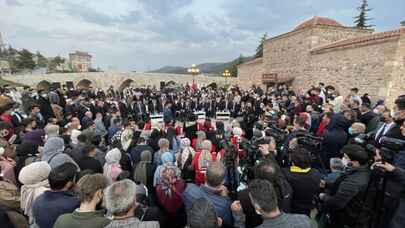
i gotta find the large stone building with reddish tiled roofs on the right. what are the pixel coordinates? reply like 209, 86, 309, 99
238, 17, 405, 106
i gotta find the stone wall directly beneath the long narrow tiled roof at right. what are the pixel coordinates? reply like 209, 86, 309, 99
306, 37, 398, 97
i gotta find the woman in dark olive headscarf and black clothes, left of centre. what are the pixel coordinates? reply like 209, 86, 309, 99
134, 150, 154, 193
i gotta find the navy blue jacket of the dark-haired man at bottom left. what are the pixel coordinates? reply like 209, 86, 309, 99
32, 191, 80, 228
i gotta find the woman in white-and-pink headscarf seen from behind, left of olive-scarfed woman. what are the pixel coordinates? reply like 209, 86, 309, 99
103, 148, 122, 182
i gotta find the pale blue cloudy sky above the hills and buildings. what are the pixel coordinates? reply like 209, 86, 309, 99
0, 0, 405, 71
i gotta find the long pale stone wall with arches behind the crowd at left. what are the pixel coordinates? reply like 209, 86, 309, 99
3, 72, 225, 89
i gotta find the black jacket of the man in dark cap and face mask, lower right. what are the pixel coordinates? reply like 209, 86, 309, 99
322, 165, 370, 227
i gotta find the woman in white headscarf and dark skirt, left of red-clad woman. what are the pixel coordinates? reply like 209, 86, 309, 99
177, 138, 195, 183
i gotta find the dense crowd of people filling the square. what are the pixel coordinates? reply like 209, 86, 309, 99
0, 83, 405, 228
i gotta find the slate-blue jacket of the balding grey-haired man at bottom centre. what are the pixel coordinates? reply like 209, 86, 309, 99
183, 184, 233, 227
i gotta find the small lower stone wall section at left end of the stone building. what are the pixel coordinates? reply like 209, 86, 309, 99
238, 58, 264, 89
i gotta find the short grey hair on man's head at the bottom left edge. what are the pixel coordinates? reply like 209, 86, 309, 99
104, 179, 136, 215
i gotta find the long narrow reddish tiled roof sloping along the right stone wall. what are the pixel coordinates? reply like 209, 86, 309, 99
311, 28, 405, 52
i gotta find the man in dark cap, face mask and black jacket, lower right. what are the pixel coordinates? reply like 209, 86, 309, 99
319, 144, 370, 228
